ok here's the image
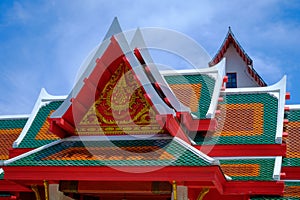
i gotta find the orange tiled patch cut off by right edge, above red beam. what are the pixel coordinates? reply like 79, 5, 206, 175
285, 122, 300, 158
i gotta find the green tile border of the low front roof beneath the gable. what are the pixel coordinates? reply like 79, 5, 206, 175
9, 139, 210, 166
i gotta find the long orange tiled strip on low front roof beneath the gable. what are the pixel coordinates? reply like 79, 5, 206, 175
43, 146, 174, 160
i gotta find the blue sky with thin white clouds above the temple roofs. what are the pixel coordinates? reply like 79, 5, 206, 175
0, 0, 300, 115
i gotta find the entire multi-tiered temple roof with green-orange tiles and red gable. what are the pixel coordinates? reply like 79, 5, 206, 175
0, 19, 300, 199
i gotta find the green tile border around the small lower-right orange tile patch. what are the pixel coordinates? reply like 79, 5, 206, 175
220, 158, 275, 181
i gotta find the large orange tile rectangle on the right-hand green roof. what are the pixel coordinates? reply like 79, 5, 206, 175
216, 103, 264, 136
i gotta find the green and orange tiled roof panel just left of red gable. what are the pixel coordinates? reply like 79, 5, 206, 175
18, 101, 62, 148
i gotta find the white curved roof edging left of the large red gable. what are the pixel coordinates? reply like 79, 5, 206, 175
13, 88, 67, 148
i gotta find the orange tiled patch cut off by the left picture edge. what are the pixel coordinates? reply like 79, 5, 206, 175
0, 128, 22, 160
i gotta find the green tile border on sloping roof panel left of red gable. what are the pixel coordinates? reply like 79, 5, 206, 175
18, 101, 63, 148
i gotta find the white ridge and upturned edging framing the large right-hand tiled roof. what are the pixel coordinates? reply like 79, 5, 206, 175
221, 76, 286, 144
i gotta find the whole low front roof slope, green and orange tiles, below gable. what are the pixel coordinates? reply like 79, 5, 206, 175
6, 136, 212, 166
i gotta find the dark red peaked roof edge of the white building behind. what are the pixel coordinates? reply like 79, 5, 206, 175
209, 27, 267, 86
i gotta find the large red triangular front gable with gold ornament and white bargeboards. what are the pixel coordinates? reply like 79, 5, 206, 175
50, 19, 196, 143
